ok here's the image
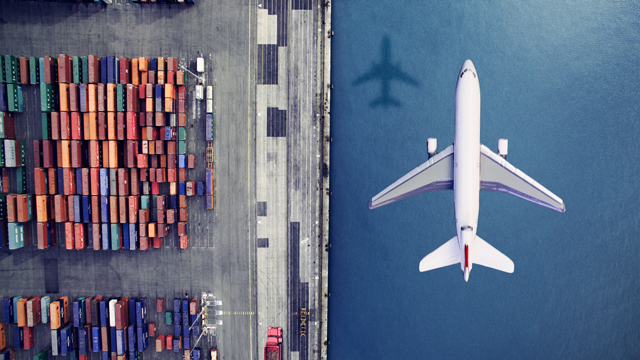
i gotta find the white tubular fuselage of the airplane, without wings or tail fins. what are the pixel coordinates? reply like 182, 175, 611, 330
453, 60, 480, 280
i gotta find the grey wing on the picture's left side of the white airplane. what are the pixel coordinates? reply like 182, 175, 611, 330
369, 145, 453, 209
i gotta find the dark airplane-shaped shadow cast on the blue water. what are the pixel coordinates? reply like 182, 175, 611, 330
353, 35, 418, 107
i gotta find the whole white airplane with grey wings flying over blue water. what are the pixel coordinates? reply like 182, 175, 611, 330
369, 60, 566, 281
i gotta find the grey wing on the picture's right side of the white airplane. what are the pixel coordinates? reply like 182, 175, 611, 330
480, 145, 566, 212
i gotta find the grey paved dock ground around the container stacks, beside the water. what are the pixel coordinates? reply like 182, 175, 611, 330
0, 0, 332, 360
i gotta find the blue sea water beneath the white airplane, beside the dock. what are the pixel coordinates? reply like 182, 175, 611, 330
329, 0, 640, 360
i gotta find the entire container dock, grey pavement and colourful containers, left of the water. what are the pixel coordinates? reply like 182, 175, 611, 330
0, 0, 331, 360
